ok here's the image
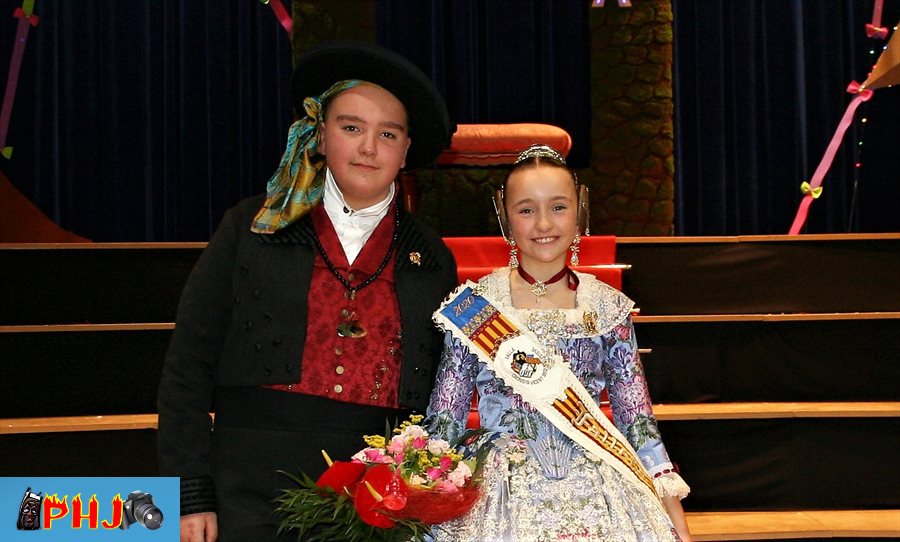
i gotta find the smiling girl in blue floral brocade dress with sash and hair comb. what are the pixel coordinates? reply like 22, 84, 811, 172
428, 145, 691, 542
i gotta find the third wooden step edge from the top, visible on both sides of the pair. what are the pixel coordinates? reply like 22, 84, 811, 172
0, 401, 900, 435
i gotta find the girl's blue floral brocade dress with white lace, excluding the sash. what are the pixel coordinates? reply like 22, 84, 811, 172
427, 268, 689, 542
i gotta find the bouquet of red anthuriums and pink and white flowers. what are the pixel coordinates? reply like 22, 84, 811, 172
276, 416, 479, 542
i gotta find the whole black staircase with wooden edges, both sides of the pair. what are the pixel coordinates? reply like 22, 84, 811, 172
0, 235, 900, 540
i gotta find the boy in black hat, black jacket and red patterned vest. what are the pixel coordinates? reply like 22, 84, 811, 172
158, 42, 457, 542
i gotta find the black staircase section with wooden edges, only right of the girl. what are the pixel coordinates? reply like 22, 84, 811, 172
617, 235, 900, 540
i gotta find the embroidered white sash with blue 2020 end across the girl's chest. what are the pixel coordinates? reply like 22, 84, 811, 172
433, 281, 664, 510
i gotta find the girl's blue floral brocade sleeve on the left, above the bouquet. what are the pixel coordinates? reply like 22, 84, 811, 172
426, 332, 478, 442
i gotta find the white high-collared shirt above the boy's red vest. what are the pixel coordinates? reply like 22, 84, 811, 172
322, 169, 394, 265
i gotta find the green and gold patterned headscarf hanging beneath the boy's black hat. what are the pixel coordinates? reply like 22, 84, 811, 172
250, 79, 362, 233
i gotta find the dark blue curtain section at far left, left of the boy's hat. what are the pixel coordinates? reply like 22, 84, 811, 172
0, 0, 291, 241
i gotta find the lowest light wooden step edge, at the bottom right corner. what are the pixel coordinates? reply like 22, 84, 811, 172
686, 510, 900, 541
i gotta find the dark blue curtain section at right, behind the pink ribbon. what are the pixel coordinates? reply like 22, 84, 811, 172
673, 0, 900, 235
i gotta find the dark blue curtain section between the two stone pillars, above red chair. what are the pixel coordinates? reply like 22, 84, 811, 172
375, 0, 591, 167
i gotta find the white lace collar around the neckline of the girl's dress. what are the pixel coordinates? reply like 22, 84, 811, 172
478, 267, 634, 338
